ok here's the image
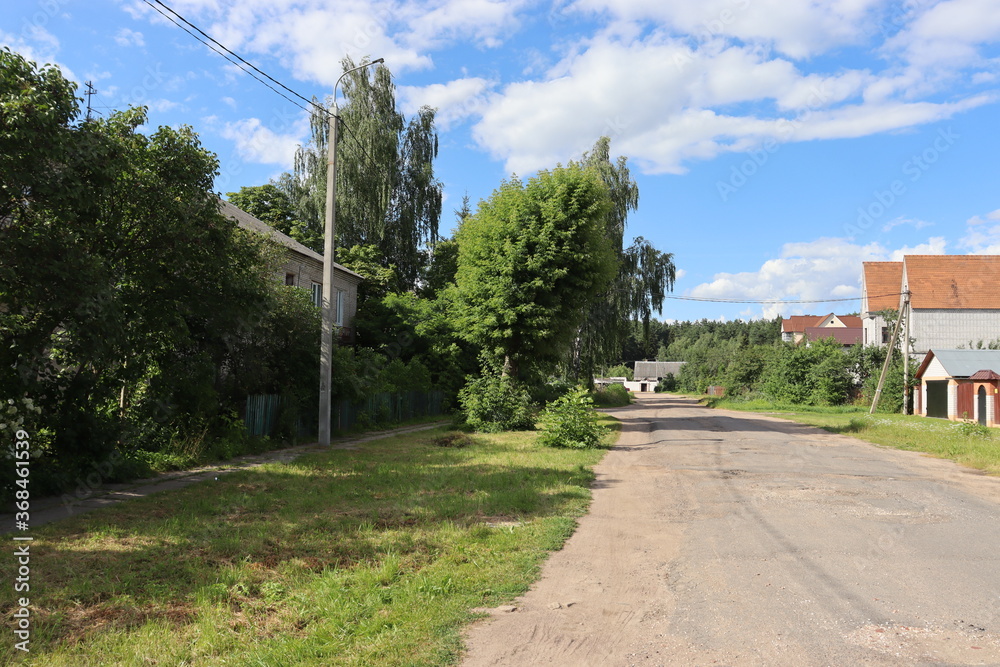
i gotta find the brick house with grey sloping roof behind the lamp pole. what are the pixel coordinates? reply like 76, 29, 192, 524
219, 199, 364, 343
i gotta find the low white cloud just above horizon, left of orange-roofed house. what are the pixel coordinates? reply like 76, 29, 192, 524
688, 236, 952, 318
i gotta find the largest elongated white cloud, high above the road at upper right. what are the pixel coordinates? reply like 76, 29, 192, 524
474, 33, 994, 173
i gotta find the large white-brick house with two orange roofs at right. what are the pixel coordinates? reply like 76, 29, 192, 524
861, 255, 1000, 356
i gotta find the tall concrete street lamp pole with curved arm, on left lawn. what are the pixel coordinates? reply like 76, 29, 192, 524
319, 58, 385, 447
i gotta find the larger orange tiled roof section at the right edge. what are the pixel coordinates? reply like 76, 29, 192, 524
903, 255, 1000, 310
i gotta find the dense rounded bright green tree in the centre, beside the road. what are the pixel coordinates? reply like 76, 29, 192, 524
456, 164, 616, 379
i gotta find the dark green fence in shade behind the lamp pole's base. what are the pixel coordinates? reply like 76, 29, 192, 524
244, 391, 444, 436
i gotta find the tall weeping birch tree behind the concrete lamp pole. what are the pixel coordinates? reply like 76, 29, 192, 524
276, 58, 442, 288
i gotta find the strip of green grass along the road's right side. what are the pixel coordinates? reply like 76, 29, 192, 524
707, 399, 1000, 475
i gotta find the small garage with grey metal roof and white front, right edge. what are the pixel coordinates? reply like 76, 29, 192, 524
914, 349, 1000, 426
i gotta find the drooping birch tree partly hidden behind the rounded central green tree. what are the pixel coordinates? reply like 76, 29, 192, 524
571, 137, 676, 383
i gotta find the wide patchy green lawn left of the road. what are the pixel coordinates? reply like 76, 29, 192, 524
0, 416, 614, 666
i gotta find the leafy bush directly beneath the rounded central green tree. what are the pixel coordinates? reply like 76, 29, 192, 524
458, 376, 535, 433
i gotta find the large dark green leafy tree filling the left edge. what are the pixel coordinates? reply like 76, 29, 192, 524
0, 50, 286, 490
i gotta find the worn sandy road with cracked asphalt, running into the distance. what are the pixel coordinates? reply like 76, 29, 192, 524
463, 395, 1000, 667
